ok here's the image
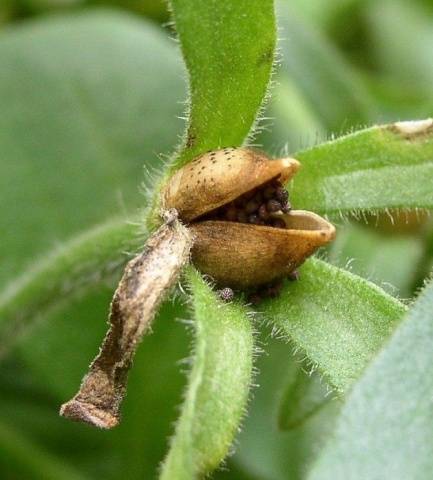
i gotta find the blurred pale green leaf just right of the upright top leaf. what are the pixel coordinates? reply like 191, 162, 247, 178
277, 0, 376, 132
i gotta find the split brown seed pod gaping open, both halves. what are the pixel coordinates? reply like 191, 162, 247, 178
163, 148, 335, 288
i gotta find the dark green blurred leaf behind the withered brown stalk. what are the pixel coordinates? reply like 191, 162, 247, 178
0, 296, 188, 480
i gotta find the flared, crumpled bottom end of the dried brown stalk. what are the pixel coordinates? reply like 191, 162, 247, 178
60, 399, 119, 430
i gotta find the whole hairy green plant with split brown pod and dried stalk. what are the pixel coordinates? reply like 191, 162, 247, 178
0, 0, 433, 480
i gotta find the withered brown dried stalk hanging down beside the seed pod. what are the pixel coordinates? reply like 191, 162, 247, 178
60, 209, 192, 428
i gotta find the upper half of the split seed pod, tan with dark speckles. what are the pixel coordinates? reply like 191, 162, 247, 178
163, 148, 300, 222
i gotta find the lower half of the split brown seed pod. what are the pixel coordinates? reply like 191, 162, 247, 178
190, 210, 335, 288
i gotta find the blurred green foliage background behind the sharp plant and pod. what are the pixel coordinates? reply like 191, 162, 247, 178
0, 0, 433, 480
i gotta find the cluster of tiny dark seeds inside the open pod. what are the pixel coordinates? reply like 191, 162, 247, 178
212, 180, 291, 228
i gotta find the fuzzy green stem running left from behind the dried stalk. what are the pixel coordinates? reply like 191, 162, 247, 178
0, 220, 144, 355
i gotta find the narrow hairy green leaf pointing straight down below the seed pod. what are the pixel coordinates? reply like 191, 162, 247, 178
161, 269, 254, 480
